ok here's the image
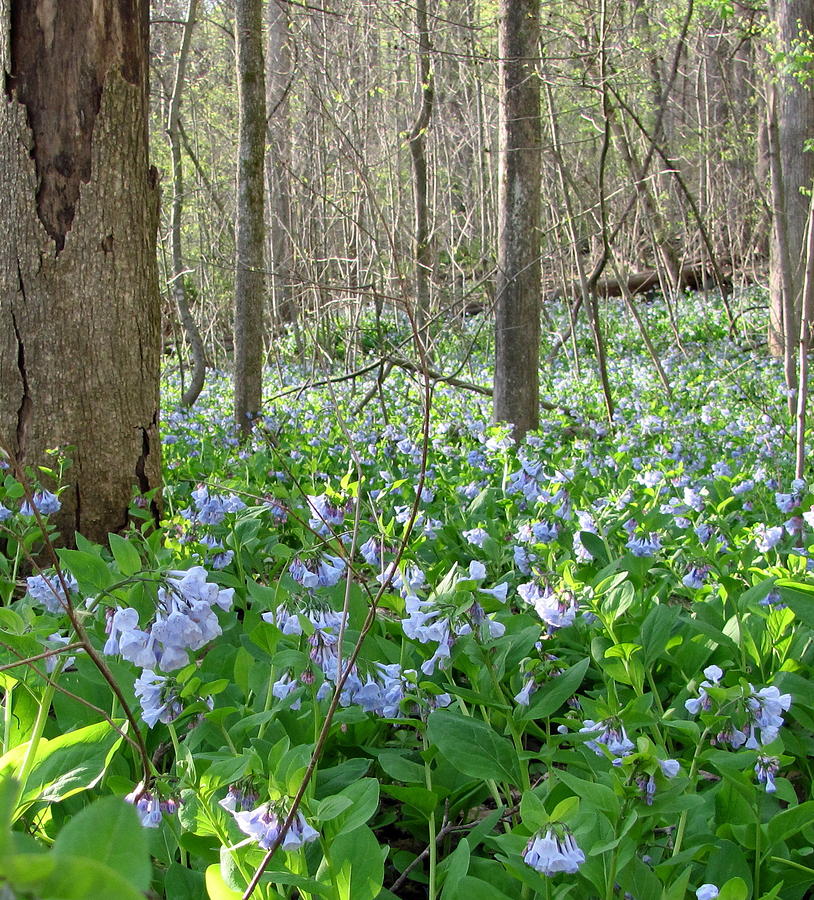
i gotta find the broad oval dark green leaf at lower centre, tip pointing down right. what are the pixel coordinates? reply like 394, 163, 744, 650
427, 709, 520, 784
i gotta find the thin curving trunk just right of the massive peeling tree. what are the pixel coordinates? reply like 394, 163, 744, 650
167, 0, 206, 406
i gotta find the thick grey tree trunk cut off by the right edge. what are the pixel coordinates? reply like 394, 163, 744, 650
769, 0, 814, 366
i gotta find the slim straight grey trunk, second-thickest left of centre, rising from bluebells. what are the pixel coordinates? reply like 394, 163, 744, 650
235, 0, 266, 434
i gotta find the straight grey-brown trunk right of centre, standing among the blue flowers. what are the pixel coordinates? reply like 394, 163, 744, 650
494, 0, 541, 440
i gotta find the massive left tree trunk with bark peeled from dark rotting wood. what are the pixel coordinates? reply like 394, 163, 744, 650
0, 0, 160, 541
